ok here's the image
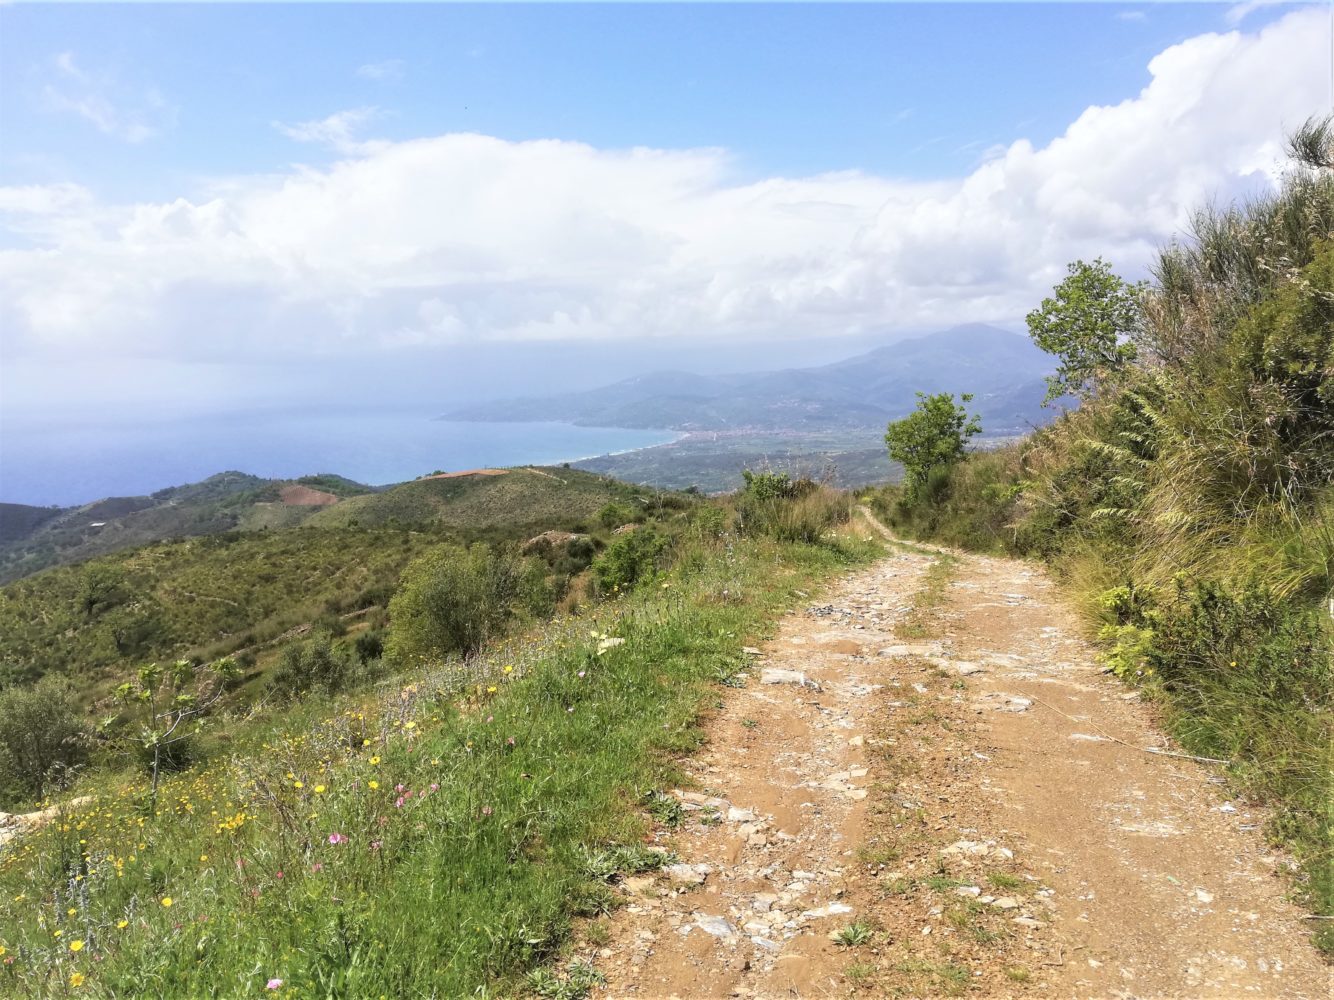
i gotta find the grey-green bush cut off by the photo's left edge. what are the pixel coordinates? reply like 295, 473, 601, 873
0, 675, 89, 801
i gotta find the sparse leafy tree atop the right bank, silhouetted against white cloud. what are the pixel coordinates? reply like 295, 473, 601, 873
1027, 257, 1145, 403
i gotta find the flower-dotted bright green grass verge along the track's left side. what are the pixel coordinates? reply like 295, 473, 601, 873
0, 528, 874, 997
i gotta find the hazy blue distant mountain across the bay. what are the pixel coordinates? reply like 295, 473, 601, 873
442, 324, 1054, 433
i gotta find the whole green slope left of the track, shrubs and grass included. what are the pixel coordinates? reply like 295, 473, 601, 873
0, 469, 875, 999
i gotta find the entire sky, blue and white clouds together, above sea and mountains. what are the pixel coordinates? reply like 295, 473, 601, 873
0, 3, 1331, 427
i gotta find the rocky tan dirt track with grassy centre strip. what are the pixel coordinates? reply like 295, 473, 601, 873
588, 525, 1331, 999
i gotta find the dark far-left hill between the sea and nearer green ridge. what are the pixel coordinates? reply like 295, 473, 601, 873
0, 472, 370, 583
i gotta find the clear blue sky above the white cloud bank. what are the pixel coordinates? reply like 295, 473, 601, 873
0, 4, 1281, 199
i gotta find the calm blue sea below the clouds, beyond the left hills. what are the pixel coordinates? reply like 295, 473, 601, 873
0, 412, 676, 507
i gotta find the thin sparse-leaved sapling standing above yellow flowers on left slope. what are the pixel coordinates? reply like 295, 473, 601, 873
116, 657, 240, 808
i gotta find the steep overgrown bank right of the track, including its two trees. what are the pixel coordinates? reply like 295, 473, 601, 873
878, 121, 1334, 952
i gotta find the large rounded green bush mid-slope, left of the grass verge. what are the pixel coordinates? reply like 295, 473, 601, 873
384, 544, 524, 664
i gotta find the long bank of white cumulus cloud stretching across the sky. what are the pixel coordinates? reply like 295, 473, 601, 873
0, 11, 1327, 359
